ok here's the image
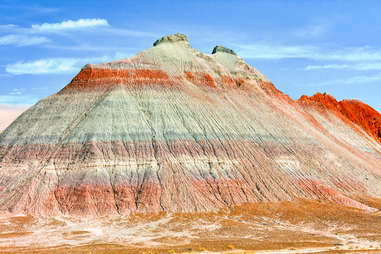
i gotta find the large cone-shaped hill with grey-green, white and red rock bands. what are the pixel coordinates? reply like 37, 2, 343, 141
0, 34, 381, 216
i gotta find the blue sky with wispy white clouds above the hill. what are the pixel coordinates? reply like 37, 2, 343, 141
0, 0, 381, 111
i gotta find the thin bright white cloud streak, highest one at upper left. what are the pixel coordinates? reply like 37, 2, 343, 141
32, 19, 109, 32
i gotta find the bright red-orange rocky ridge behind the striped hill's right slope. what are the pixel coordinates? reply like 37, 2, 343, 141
297, 93, 381, 143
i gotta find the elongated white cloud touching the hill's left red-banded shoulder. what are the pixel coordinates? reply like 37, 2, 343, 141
5, 56, 111, 75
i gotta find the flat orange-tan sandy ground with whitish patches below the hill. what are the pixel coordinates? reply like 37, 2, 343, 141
0, 200, 381, 254
